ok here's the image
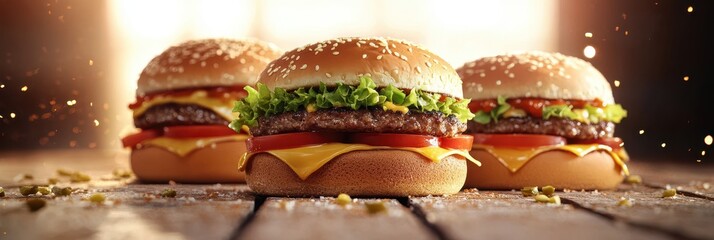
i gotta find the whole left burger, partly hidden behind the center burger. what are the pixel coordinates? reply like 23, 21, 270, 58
122, 39, 281, 183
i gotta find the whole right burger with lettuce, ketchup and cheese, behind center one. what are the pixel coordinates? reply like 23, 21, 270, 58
457, 51, 628, 189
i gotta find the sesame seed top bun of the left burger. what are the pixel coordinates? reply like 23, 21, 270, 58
136, 39, 282, 96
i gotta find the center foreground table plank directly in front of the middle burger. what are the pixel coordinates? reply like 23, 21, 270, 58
240, 197, 435, 240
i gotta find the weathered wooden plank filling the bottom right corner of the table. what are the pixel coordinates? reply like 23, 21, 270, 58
559, 185, 714, 239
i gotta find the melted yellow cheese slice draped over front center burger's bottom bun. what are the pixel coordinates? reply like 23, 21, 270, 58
238, 143, 481, 180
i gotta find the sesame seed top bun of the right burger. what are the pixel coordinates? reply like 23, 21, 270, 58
457, 51, 615, 104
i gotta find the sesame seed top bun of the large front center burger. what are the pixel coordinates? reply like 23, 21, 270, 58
259, 38, 463, 98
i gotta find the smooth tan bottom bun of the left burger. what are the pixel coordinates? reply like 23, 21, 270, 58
131, 141, 246, 183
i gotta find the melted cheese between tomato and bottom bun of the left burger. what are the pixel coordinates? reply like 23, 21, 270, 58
138, 134, 248, 157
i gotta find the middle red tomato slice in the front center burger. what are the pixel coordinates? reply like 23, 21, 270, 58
349, 133, 436, 147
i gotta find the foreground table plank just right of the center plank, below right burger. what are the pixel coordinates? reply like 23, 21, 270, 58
411, 191, 669, 239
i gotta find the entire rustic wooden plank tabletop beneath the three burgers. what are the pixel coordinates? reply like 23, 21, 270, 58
0, 150, 714, 239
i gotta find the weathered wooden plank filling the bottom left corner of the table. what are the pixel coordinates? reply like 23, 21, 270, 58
0, 185, 253, 239
